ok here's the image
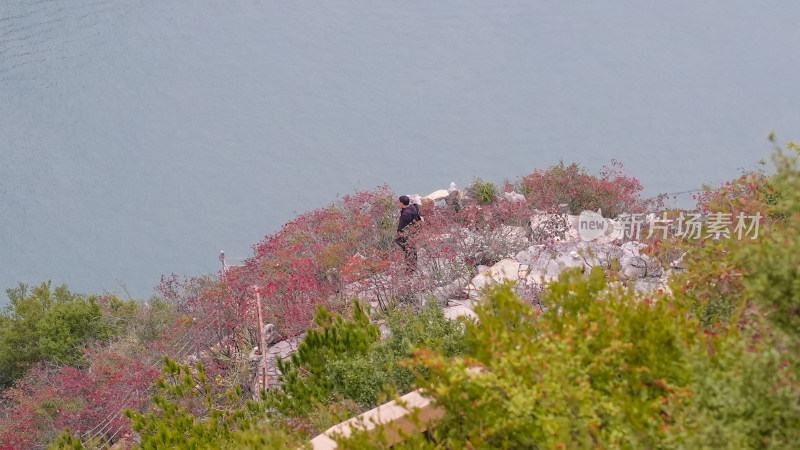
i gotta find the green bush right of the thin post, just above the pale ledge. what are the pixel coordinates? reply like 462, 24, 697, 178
269, 302, 464, 417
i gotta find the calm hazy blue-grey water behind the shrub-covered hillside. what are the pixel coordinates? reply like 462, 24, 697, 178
0, 0, 800, 302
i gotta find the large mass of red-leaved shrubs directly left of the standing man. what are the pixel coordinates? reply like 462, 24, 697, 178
214, 187, 396, 336
